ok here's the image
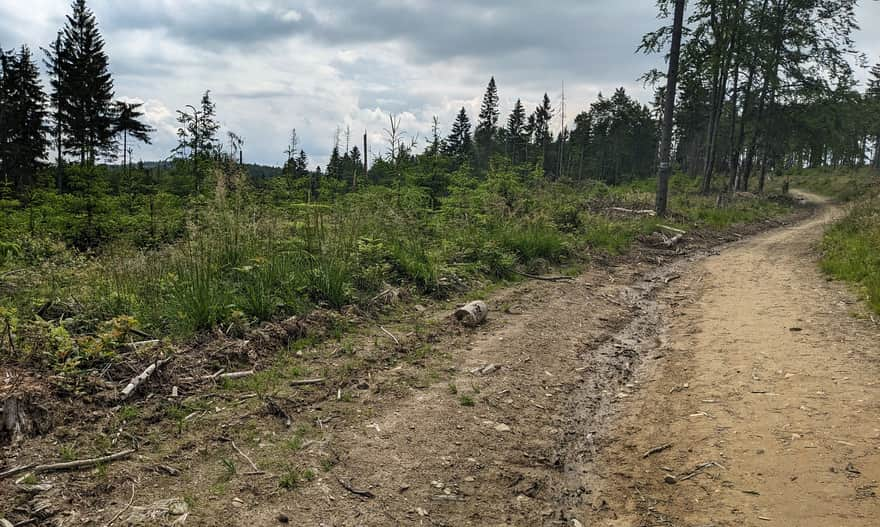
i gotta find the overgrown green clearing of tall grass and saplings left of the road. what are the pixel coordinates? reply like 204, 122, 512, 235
0, 166, 790, 381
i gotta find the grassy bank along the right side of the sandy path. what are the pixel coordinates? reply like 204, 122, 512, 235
776, 169, 880, 313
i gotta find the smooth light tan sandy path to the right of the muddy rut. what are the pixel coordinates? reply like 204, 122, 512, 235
585, 196, 880, 527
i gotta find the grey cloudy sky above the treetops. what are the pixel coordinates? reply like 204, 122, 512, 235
0, 0, 880, 165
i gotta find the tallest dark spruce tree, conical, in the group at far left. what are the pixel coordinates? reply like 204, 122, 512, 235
50, 0, 115, 165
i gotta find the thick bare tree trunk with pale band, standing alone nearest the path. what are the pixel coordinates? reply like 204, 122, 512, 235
656, 0, 684, 216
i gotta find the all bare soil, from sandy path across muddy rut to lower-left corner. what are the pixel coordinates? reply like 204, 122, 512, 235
0, 196, 880, 527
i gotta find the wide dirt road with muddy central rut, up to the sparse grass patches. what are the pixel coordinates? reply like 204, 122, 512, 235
230, 197, 880, 526
